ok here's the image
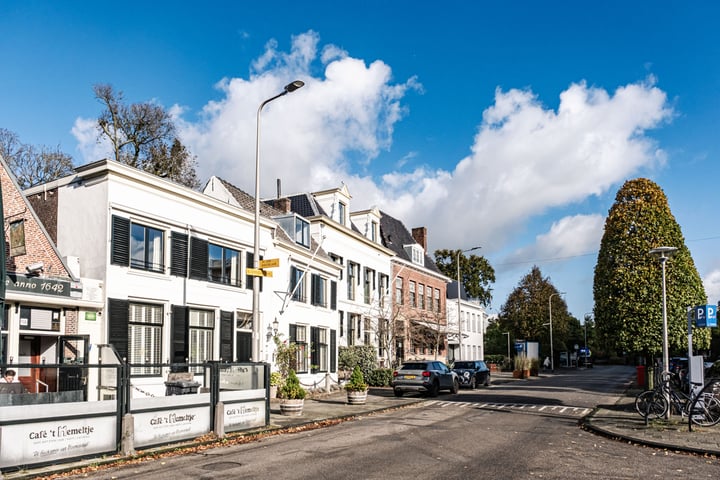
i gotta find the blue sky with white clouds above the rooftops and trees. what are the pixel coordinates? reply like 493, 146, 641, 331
0, 0, 720, 318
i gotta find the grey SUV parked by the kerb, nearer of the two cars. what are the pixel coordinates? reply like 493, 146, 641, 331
390, 360, 460, 397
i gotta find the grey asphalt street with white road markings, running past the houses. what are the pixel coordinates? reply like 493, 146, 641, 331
62, 367, 720, 480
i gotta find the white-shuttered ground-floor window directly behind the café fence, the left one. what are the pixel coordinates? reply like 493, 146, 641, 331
128, 303, 163, 375
